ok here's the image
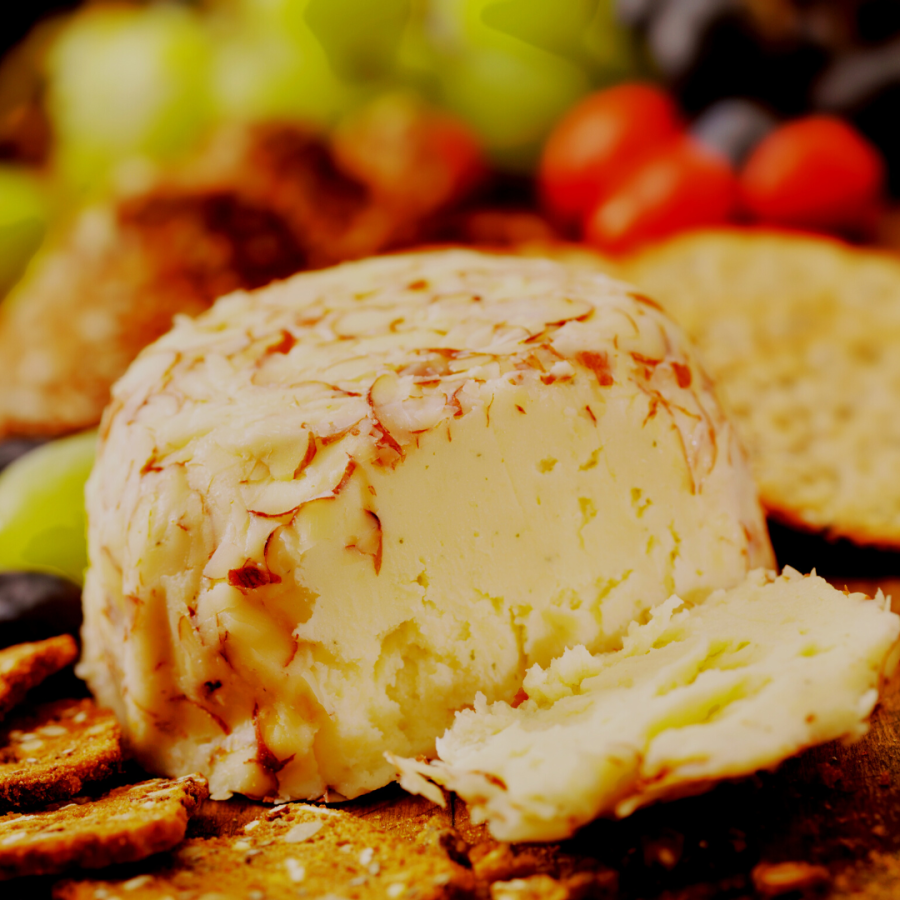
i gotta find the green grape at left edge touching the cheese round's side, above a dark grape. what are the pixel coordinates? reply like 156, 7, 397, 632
0, 431, 97, 583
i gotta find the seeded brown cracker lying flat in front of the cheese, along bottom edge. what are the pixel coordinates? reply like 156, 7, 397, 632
54, 803, 475, 900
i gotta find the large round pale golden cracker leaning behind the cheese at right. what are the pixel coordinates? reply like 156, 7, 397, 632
621, 230, 900, 548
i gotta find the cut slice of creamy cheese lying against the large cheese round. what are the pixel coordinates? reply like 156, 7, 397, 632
395, 569, 900, 841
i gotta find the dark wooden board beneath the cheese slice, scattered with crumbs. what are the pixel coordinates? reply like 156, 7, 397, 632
0, 578, 900, 900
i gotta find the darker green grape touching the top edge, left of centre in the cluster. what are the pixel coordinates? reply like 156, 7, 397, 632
304, 0, 411, 80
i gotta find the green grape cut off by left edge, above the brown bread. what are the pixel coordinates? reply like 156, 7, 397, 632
0, 166, 49, 297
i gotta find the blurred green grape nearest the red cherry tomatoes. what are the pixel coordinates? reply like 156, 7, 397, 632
439, 41, 591, 172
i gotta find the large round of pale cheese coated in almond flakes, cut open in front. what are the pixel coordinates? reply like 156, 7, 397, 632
79, 251, 772, 798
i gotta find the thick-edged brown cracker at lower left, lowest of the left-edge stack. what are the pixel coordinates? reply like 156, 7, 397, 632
0, 775, 208, 878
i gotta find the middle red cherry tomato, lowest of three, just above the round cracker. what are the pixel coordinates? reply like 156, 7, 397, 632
584, 135, 738, 252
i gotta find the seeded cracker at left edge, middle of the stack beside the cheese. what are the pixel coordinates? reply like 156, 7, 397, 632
0, 699, 123, 807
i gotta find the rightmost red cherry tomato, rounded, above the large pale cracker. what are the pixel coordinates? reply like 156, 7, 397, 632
741, 116, 885, 230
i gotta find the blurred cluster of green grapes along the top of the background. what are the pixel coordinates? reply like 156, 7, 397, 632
42, 0, 636, 185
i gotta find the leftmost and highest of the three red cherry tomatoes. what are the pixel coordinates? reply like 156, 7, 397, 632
538, 84, 683, 232
